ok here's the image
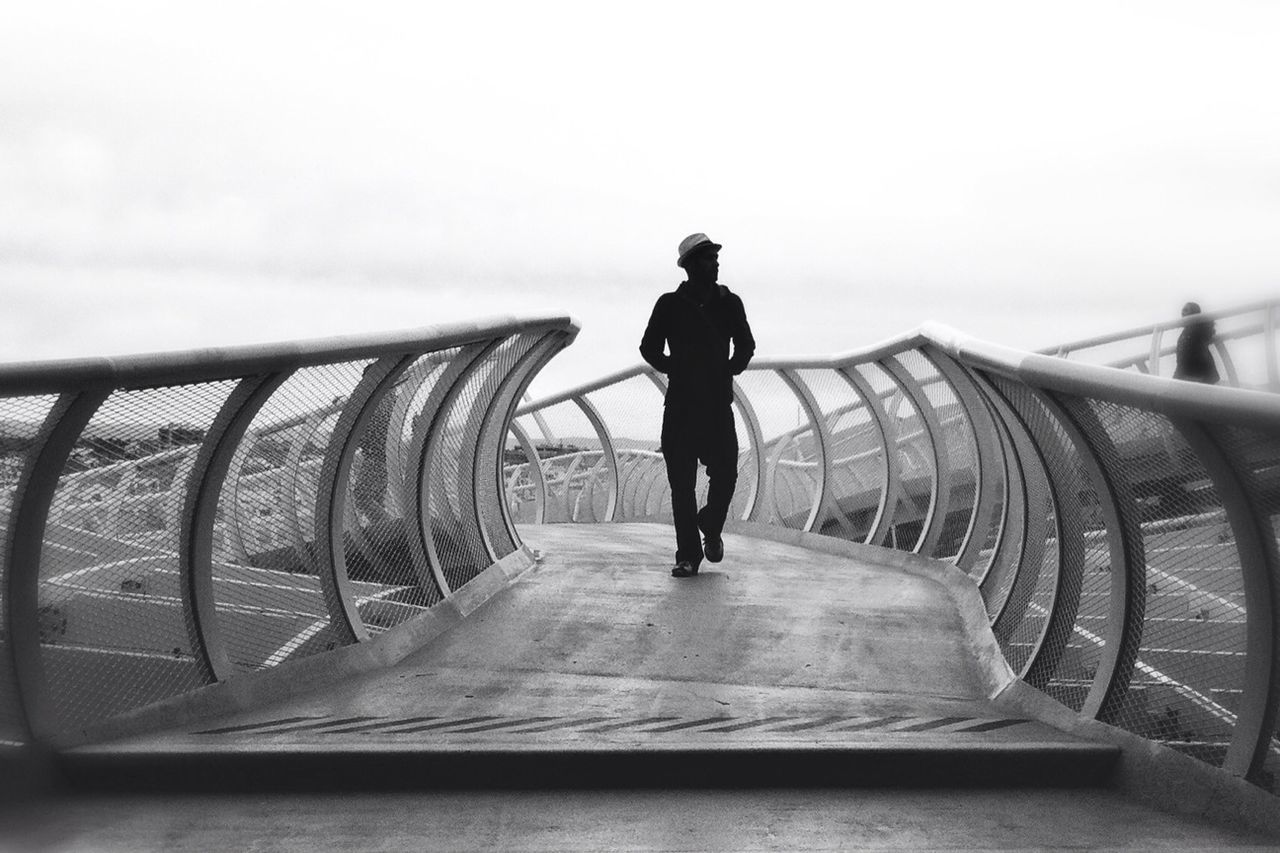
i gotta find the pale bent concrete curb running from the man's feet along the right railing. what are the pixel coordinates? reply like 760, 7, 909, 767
724, 521, 1018, 699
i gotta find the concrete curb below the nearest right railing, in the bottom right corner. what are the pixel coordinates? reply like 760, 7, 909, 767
996, 680, 1280, 838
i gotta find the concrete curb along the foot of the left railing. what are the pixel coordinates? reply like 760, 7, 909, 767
66, 546, 536, 748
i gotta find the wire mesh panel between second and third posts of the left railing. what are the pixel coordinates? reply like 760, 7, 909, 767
212, 360, 370, 670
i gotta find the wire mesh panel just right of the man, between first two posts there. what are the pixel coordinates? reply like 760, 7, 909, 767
737, 370, 822, 530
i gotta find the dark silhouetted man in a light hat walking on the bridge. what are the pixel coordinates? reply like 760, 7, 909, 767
640, 234, 755, 578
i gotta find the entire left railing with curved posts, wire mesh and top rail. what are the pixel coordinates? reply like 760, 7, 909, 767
0, 318, 577, 744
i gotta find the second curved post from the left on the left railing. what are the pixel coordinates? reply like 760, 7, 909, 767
173, 373, 291, 681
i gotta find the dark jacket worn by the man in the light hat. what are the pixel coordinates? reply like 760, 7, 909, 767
640, 282, 755, 406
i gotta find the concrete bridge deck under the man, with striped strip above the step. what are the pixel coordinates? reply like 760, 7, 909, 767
87, 524, 1084, 752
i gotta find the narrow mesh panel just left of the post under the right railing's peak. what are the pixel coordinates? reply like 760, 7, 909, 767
897, 351, 978, 560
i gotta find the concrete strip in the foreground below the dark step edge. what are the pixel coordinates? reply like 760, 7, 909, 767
0, 789, 1280, 853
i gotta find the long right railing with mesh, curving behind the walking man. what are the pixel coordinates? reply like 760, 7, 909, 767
504, 325, 1280, 788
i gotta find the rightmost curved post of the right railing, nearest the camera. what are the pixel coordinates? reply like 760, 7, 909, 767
1174, 419, 1280, 781
